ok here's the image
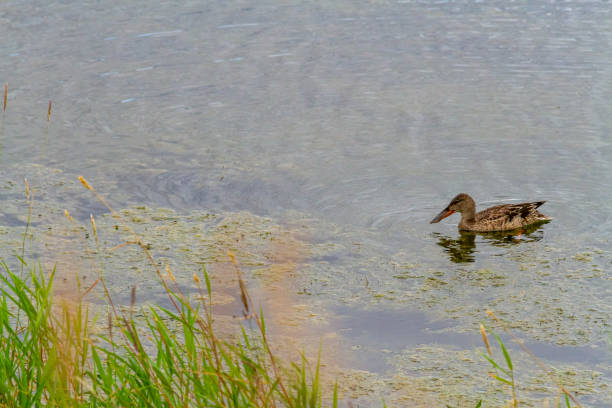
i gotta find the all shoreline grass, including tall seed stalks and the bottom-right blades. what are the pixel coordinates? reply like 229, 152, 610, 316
0, 178, 580, 408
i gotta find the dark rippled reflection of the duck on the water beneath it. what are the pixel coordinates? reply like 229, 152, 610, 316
432, 223, 545, 263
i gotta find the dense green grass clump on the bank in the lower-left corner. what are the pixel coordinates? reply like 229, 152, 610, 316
0, 262, 338, 407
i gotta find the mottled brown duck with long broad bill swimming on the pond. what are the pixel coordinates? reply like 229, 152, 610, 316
430, 193, 552, 232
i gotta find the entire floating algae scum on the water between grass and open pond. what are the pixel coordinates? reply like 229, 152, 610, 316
0, 167, 609, 406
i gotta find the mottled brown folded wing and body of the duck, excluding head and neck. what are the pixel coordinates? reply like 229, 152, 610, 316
476, 201, 550, 231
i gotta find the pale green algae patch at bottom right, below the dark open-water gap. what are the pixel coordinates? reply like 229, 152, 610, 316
386, 345, 612, 407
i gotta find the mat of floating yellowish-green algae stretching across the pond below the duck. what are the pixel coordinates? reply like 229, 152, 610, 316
0, 165, 611, 406
